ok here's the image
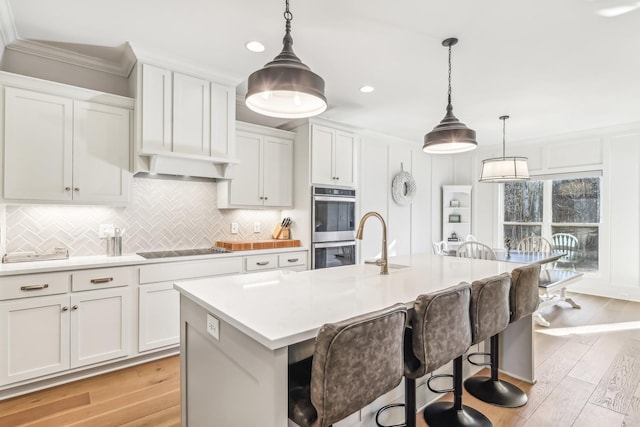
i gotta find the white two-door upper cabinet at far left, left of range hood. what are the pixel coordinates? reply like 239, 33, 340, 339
3, 84, 132, 204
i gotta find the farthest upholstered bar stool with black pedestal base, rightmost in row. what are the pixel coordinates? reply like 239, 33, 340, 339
464, 264, 540, 408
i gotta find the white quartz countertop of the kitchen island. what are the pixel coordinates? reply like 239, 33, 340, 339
175, 254, 521, 350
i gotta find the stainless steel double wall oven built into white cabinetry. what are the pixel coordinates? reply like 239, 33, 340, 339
311, 187, 356, 270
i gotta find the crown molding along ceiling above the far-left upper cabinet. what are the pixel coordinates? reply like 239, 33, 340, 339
6, 38, 136, 77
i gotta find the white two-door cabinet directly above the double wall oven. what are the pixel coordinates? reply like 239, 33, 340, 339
311, 124, 357, 187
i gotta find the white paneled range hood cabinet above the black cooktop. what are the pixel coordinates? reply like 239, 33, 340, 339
136, 64, 235, 178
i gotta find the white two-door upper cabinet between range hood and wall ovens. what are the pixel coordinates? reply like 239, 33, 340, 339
218, 122, 294, 208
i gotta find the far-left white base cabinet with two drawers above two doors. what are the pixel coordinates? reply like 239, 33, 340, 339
0, 267, 135, 388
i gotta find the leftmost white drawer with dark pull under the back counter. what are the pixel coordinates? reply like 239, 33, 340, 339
0, 273, 71, 300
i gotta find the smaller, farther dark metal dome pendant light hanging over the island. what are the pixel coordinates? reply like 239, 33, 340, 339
422, 38, 478, 154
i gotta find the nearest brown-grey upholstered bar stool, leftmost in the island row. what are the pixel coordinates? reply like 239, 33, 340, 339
289, 304, 407, 427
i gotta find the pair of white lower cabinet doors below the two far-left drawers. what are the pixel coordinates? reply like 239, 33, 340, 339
0, 287, 129, 385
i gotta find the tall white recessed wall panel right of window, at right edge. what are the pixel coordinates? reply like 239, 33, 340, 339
601, 133, 640, 288
